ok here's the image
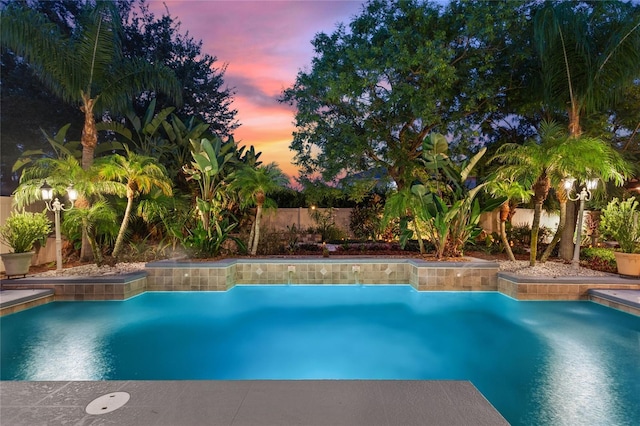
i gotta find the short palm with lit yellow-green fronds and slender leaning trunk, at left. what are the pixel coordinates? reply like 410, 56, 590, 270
96, 147, 172, 259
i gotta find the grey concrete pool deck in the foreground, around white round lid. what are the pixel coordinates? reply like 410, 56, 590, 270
0, 380, 509, 426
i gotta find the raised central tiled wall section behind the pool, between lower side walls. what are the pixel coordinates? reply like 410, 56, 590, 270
146, 260, 498, 291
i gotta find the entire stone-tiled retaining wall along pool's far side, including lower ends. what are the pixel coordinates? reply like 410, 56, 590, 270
2, 258, 640, 314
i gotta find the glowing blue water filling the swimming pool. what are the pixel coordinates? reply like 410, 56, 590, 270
0, 286, 640, 425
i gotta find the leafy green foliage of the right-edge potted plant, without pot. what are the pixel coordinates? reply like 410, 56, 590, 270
600, 197, 640, 253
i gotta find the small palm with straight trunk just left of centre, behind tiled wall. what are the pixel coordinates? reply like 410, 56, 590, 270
231, 163, 288, 256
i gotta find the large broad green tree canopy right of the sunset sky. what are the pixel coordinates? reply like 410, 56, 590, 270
282, 0, 526, 187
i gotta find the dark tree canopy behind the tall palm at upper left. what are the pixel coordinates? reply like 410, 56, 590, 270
0, 0, 238, 195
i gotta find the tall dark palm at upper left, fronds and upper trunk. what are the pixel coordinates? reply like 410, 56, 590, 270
0, 1, 182, 170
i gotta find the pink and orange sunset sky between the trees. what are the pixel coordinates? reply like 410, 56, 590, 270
149, 0, 363, 176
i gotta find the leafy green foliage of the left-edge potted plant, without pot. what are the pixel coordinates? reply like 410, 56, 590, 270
0, 211, 51, 253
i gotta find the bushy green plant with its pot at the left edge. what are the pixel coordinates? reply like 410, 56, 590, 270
0, 211, 51, 276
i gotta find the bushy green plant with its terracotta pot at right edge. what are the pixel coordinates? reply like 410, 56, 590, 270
600, 197, 640, 277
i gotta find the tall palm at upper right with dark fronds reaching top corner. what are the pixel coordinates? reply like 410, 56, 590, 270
534, 2, 640, 259
